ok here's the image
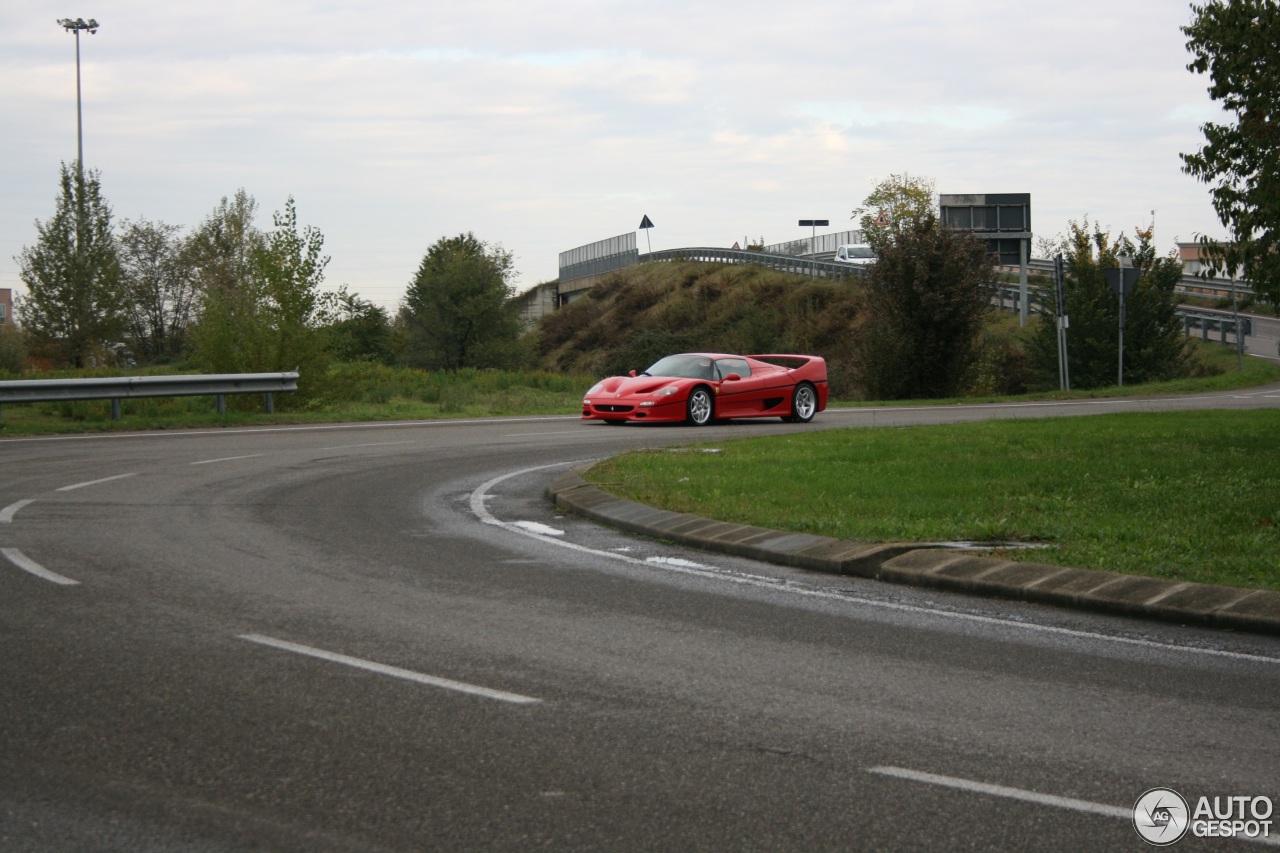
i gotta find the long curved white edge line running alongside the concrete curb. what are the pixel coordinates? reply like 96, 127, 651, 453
470, 459, 1280, 666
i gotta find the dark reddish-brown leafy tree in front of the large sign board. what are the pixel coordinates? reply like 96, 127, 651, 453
858, 211, 995, 400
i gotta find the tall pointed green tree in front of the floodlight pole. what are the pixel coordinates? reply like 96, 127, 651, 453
14, 163, 125, 368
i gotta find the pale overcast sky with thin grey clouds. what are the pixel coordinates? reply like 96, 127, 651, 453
0, 0, 1224, 309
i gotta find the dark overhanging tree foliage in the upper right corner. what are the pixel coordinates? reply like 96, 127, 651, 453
1181, 0, 1280, 302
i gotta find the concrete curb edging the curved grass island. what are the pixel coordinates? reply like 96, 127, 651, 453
547, 470, 1280, 634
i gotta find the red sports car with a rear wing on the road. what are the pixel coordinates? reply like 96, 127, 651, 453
582, 352, 827, 427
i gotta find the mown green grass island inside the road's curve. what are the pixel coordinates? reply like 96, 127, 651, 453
589, 410, 1280, 589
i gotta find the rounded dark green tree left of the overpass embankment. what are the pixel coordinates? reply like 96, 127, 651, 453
398, 232, 520, 370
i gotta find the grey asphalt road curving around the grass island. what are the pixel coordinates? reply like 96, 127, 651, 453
0, 388, 1280, 852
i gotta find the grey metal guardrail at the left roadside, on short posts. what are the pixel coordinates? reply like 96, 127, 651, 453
0, 373, 298, 420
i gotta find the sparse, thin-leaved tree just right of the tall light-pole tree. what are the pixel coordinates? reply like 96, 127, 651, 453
118, 219, 196, 364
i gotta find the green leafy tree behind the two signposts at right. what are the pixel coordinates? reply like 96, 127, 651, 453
1028, 218, 1190, 388
